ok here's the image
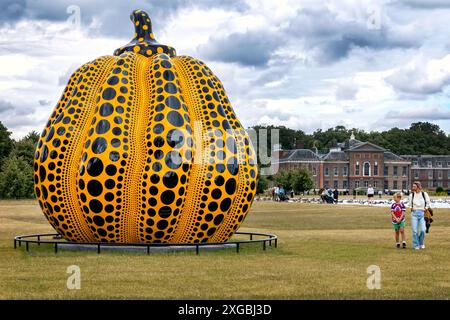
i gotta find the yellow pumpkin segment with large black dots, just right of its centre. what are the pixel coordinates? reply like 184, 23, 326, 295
139, 54, 193, 242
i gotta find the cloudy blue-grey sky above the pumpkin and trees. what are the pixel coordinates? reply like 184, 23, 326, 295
0, 0, 450, 139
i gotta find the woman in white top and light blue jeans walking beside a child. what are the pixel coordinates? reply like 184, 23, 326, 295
409, 181, 430, 250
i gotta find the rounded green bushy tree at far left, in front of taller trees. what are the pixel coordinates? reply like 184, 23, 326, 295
0, 154, 34, 199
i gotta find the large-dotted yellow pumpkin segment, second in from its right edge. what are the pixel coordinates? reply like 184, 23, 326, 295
172, 56, 243, 242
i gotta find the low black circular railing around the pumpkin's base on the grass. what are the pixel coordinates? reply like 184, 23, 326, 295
14, 232, 278, 255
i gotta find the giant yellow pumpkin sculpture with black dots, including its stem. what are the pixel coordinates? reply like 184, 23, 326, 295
34, 10, 257, 243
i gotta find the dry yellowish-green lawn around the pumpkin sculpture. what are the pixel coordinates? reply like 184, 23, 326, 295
0, 200, 450, 299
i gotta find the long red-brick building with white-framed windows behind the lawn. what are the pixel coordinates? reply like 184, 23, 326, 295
274, 135, 450, 191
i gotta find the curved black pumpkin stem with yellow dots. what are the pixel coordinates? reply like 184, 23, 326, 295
114, 10, 176, 57
